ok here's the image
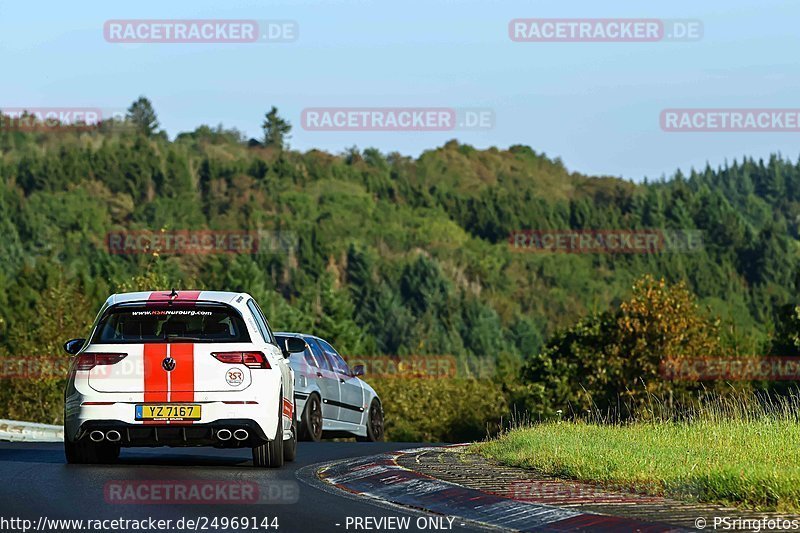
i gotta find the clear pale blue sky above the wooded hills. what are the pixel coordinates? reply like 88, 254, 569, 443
0, 0, 800, 180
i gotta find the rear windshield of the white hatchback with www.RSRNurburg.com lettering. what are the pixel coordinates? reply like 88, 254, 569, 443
92, 303, 250, 344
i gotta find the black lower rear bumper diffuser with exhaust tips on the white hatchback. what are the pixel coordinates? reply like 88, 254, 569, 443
72, 418, 270, 448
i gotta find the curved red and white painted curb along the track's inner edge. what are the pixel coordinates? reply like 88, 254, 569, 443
317, 448, 690, 533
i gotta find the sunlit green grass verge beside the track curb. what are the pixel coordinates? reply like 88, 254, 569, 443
471, 396, 800, 512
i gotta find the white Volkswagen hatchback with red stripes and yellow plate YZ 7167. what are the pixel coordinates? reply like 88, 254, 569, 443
64, 290, 305, 467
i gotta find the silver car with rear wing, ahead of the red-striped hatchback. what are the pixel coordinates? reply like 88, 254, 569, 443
275, 332, 383, 442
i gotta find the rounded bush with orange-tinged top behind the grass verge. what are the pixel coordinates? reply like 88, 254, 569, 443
523, 276, 724, 416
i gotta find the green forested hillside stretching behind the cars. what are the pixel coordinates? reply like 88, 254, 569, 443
0, 103, 800, 432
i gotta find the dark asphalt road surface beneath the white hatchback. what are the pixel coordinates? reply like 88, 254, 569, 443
0, 442, 476, 533
